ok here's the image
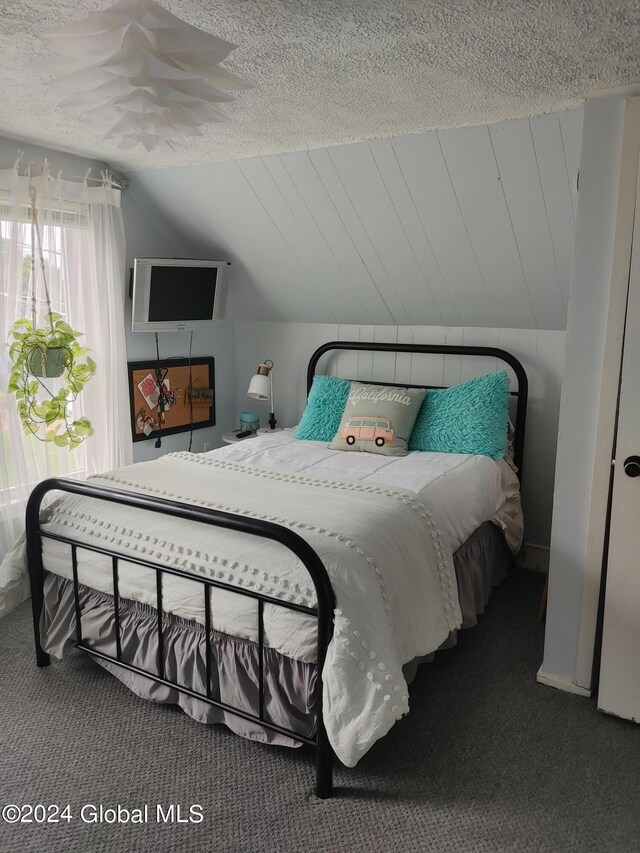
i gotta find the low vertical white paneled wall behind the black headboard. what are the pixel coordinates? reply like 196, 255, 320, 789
228, 322, 564, 552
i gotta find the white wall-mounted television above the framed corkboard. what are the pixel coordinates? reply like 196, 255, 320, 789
131, 258, 230, 332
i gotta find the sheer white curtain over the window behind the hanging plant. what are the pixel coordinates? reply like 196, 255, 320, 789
0, 170, 131, 617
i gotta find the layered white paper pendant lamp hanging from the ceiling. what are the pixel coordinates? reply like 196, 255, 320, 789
37, 0, 251, 151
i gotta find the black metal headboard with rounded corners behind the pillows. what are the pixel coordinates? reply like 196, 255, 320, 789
307, 341, 529, 482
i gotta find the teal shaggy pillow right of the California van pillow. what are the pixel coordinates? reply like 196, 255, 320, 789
409, 370, 509, 459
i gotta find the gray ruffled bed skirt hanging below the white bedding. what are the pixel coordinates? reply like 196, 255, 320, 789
40, 522, 512, 746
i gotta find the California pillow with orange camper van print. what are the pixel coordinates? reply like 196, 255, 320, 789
329, 382, 427, 456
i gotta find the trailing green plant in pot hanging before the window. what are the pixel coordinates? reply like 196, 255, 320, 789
7, 187, 96, 450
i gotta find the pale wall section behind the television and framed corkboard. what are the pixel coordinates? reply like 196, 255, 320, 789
122, 186, 235, 462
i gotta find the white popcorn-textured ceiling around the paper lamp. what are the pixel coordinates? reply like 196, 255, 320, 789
0, 0, 640, 171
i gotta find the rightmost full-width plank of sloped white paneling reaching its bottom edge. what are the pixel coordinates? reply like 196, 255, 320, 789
489, 121, 566, 329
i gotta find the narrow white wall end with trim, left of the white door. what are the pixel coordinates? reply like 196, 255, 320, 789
539, 95, 640, 690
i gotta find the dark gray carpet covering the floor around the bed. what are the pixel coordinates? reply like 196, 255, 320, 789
0, 571, 640, 853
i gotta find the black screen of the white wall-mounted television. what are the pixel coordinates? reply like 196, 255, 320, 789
148, 266, 218, 323
